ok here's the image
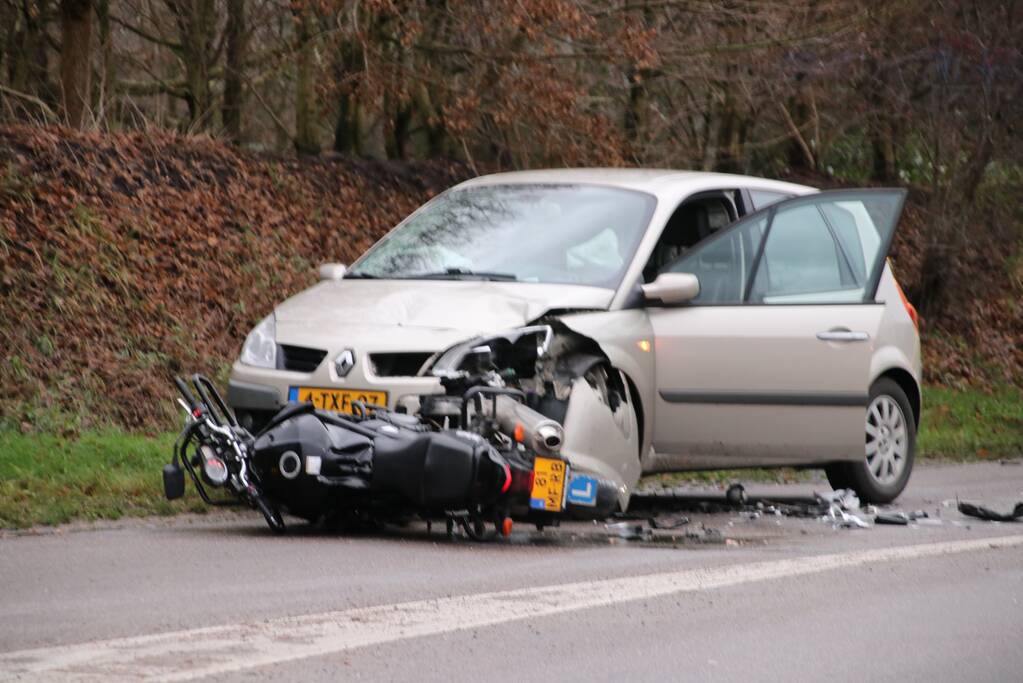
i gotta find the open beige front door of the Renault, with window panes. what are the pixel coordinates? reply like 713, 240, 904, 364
649, 189, 905, 468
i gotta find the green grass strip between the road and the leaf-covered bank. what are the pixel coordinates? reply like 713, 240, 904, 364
0, 388, 1023, 529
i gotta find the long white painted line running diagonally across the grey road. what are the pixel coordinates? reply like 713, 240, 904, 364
0, 535, 1023, 681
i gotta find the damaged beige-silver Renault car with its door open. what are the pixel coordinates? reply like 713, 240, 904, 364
228, 169, 921, 509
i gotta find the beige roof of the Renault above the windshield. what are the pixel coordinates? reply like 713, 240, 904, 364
453, 169, 816, 196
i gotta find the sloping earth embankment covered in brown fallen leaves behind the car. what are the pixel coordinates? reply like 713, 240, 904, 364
0, 127, 1023, 428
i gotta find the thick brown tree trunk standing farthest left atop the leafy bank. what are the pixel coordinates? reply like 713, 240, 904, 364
60, 0, 92, 128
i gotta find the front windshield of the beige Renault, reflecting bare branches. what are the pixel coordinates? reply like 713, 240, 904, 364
345, 185, 656, 288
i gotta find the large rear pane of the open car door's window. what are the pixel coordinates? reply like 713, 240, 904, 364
750, 192, 901, 304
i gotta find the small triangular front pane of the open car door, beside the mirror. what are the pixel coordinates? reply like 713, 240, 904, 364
662, 216, 767, 304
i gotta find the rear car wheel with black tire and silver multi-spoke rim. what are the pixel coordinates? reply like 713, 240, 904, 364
825, 377, 917, 504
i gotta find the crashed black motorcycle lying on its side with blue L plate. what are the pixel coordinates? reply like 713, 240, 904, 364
164, 325, 619, 540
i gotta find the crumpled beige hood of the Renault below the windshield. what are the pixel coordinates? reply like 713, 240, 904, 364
276, 280, 614, 347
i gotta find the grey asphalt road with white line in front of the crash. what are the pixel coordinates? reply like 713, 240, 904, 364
0, 463, 1023, 681
